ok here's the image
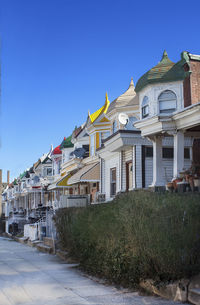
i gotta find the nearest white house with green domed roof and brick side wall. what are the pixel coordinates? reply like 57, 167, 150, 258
134, 51, 200, 188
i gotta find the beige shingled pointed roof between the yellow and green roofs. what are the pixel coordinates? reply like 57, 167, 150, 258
107, 78, 139, 113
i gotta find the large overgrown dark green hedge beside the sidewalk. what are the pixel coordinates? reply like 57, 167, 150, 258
55, 191, 200, 285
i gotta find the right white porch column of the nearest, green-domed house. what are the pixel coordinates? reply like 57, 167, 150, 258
173, 131, 184, 178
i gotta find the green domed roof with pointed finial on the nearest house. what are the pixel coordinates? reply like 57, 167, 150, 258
135, 51, 187, 92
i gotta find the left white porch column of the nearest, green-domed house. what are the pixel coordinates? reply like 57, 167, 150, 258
152, 136, 165, 186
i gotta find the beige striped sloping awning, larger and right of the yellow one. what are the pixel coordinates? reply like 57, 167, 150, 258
68, 162, 100, 185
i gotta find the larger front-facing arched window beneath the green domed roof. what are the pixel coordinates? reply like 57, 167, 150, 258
158, 90, 176, 113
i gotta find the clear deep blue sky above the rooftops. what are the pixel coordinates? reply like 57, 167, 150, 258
0, 0, 200, 180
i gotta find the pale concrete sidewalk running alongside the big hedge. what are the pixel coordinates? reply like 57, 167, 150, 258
0, 237, 189, 305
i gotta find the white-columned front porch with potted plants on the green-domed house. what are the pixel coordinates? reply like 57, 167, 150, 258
135, 103, 200, 191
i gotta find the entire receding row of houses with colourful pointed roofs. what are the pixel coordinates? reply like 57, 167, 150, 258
3, 51, 200, 238
